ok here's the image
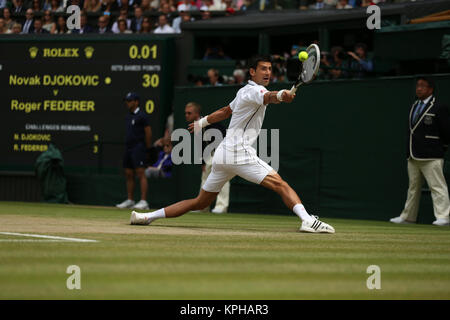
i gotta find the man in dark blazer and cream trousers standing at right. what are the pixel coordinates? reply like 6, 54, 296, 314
390, 77, 450, 226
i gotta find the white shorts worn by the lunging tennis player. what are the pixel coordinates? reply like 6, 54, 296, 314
202, 147, 275, 192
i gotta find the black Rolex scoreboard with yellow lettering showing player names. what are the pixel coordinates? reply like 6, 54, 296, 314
0, 35, 174, 168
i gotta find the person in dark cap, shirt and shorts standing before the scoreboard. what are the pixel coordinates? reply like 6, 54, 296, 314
116, 92, 152, 209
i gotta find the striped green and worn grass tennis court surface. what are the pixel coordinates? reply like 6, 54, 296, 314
0, 202, 450, 300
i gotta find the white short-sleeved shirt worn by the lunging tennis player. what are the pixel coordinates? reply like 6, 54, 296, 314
220, 80, 268, 164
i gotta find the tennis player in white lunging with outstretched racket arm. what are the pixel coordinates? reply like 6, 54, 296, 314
130, 56, 335, 233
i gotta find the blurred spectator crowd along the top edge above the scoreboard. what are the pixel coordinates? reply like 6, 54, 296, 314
0, 0, 422, 34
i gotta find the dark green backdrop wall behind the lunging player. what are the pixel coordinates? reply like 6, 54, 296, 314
174, 75, 450, 222
